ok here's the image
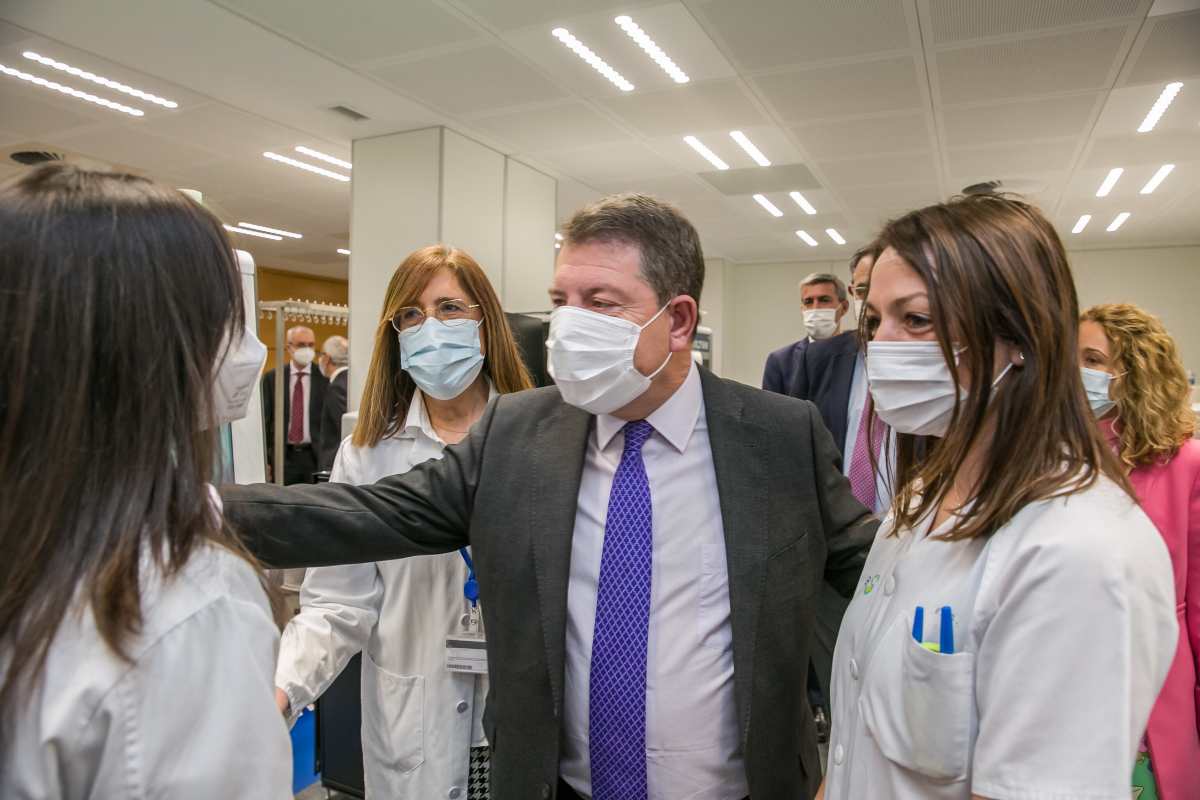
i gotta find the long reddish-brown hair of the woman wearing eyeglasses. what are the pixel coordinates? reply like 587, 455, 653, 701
352, 245, 533, 447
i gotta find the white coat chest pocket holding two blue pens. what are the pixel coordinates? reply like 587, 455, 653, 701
859, 616, 976, 783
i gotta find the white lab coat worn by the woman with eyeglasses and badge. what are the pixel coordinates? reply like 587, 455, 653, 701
275, 391, 494, 800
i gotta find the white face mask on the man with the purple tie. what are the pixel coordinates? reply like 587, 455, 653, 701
546, 306, 672, 414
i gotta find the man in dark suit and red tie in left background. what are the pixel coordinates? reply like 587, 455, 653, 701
262, 325, 329, 483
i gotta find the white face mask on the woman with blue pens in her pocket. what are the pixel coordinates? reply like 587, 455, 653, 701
866, 342, 1013, 437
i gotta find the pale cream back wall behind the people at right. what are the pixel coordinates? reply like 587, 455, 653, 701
706, 247, 1200, 386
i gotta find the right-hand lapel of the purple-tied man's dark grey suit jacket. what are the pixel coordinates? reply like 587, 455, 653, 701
700, 369, 768, 744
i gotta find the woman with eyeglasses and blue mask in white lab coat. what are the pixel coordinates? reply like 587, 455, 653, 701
275, 245, 532, 800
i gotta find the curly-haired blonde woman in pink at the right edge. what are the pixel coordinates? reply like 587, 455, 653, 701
1079, 305, 1200, 800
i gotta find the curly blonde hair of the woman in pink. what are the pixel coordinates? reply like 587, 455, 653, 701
1080, 303, 1196, 470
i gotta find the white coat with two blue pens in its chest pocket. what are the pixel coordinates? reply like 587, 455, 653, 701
826, 479, 1177, 800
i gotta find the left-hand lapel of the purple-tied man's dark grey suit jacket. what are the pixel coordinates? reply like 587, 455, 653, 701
529, 403, 592, 716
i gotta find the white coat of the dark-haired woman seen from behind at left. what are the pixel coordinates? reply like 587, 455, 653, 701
0, 545, 292, 800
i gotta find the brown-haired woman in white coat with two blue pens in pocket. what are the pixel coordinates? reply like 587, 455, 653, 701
824, 196, 1177, 800
